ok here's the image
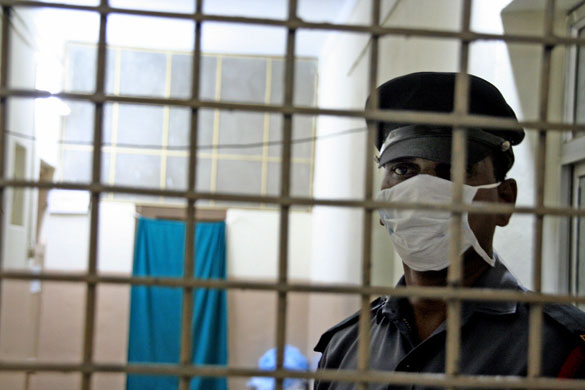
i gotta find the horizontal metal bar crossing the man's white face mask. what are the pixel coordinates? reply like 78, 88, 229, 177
0, 180, 585, 217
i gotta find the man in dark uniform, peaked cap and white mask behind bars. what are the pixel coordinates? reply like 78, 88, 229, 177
315, 72, 585, 390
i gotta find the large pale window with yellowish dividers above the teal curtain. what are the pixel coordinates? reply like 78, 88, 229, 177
61, 43, 317, 203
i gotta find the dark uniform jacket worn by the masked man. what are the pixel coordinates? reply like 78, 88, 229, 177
315, 261, 585, 390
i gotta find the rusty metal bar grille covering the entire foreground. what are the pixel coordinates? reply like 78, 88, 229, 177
0, 0, 585, 390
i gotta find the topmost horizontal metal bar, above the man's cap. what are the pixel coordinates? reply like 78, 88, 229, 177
5, 0, 585, 46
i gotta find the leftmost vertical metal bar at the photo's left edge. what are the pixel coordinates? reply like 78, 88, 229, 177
0, 3, 12, 350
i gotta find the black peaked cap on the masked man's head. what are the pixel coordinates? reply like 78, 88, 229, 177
368, 72, 524, 169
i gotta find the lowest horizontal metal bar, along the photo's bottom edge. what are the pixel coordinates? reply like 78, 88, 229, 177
0, 361, 585, 390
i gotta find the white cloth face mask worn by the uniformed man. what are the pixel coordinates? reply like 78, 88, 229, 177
376, 175, 500, 271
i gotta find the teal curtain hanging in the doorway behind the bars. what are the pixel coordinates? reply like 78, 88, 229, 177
126, 218, 227, 390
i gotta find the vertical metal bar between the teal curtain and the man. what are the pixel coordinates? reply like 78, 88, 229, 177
276, 0, 297, 390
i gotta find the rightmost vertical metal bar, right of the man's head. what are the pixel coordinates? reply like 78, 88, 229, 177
528, 0, 556, 378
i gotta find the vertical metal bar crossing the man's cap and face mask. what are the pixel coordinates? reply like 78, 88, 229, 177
445, 0, 472, 384
